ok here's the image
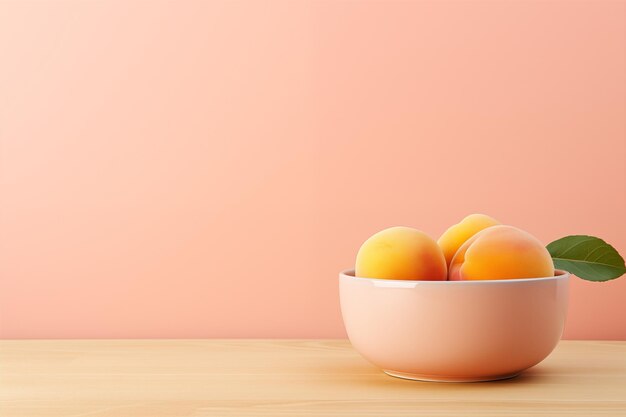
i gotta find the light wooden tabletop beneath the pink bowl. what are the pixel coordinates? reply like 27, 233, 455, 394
0, 340, 626, 417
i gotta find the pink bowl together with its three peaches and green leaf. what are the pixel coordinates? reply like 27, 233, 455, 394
339, 215, 626, 382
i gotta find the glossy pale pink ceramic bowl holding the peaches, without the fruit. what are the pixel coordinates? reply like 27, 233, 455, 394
339, 270, 569, 382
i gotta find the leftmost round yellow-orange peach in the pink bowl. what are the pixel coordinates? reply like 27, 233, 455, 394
355, 226, 447, 281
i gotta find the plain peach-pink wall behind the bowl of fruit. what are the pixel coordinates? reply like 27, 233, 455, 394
0, 0, 626, 339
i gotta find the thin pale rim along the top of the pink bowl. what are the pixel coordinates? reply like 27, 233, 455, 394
339, 268, 570, 288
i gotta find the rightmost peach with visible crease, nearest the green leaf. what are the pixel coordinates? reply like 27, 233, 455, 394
448, 226, 554, 281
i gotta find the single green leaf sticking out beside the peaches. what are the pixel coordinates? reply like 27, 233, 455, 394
547, 235, 626, 281
